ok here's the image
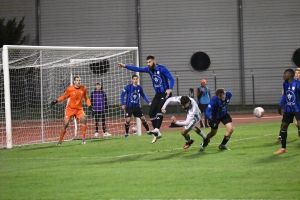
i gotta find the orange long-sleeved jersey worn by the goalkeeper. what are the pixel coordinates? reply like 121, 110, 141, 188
57, 85, 91, 110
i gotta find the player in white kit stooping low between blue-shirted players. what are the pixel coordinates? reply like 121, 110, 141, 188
161, 96, 206, 149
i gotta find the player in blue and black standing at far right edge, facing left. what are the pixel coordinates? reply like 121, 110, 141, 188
274, 69, 300, 154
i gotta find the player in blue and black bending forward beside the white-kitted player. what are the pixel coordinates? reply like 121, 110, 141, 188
200, 88, 234, 151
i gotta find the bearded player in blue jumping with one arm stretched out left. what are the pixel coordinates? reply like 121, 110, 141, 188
118, 55, 174, 140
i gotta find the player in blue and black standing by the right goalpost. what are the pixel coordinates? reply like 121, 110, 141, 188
121, 75, 151, 137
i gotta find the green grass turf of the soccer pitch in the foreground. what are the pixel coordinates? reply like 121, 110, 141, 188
0, 122, 300, 199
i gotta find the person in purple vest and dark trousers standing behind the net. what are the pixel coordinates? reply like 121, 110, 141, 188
91, 83, 111, 137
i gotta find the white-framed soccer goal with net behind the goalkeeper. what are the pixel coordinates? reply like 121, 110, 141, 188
0, 45, 141, 148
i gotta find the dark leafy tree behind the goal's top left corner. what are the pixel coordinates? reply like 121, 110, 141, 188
0, 17, 26, 48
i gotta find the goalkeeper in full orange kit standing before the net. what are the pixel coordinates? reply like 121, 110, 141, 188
51, 76, 94, 146
